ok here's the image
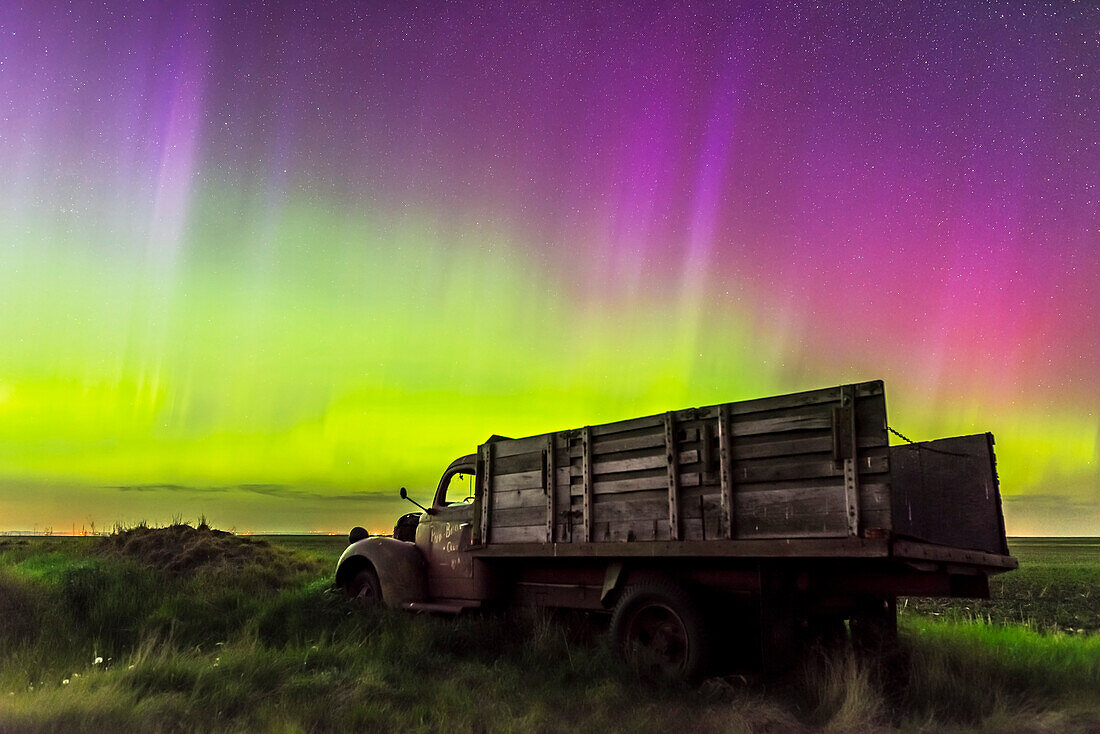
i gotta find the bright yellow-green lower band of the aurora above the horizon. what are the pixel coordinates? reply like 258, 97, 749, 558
0, 190, 1097, 533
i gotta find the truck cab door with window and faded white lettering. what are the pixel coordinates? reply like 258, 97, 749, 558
417, 457, 476, 599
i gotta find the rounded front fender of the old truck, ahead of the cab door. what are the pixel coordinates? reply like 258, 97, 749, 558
337, 538, 428, 609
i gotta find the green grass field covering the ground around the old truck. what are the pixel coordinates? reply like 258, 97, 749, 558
0, 528, 1100, 732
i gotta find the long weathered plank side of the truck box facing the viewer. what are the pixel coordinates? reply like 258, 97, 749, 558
483, 382, 893, 543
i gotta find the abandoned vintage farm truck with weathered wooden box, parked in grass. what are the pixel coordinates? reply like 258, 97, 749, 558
336, 382, 1016, 677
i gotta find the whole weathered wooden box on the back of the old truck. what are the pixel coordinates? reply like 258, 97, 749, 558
473, 381, 1014, 568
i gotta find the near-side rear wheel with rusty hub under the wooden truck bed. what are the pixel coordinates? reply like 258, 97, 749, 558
611, 581, 708, 680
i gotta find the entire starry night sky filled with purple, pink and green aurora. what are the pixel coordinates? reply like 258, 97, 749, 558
0, 1, 1100, 535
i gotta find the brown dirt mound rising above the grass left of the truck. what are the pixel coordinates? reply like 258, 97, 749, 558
97, 524, 309, 574
